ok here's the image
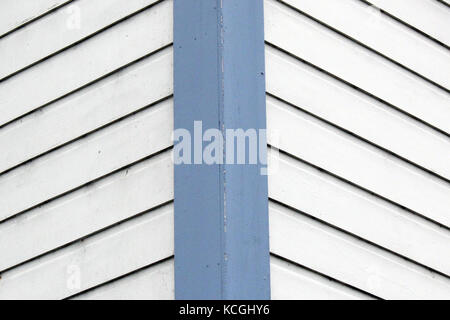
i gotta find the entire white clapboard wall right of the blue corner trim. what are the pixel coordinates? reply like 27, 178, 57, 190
265, 0, 450, 299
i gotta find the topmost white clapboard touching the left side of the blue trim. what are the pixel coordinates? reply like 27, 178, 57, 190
0, 1, 173, 125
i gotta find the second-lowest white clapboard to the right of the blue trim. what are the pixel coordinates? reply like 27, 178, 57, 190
269, 203, 450, 299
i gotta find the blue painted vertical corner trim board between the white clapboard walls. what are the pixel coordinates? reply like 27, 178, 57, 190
174, 0, 270, 299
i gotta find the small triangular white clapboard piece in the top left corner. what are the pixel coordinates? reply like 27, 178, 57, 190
0, 0, 72, 36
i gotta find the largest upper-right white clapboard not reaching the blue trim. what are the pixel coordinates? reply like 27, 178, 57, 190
284, 0, 450, 88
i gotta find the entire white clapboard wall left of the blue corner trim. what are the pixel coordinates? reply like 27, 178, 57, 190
0, 0, 174, 299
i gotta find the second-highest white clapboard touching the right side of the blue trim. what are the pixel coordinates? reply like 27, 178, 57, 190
266, 46, 450, 179
